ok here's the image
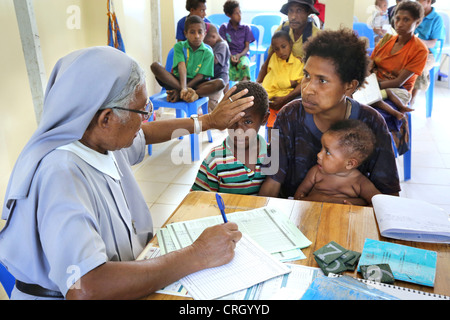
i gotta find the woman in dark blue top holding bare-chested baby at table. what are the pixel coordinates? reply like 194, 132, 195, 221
259, 29, 400, 203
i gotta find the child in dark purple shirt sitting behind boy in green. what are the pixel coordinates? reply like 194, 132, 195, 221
219, 0, 255, 81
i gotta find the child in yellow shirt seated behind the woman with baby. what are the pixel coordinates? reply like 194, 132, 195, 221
262, 30, 303, 141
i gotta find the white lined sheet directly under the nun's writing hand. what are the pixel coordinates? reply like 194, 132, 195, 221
180, 234, 291, 300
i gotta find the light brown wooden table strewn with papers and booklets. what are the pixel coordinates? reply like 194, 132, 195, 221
144, 191, 450, 299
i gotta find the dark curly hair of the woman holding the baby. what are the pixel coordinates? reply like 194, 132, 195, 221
304, 28, 369, 88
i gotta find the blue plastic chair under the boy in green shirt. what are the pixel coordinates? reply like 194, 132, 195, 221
148, 48, 212, 161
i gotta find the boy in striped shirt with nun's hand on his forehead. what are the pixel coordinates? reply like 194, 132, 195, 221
191, 81, 269, 195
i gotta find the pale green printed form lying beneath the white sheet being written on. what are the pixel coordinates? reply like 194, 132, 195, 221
163, 207, 311, 256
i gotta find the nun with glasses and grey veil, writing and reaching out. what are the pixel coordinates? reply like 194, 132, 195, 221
0, 47, 253, 299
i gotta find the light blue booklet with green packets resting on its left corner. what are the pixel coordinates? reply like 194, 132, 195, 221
358, 239, 437, 287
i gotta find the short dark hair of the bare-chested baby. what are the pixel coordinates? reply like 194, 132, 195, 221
326, 119, 376, 164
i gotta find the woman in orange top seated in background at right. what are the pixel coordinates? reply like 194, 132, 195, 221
371, 1, 428, 131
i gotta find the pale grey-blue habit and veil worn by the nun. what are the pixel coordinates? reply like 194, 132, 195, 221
0, 47, 153, 299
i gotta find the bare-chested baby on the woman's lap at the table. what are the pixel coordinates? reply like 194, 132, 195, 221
294, 120, 380, 205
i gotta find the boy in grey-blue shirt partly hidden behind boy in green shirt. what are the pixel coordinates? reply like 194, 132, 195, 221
203, 23, 230, 112
